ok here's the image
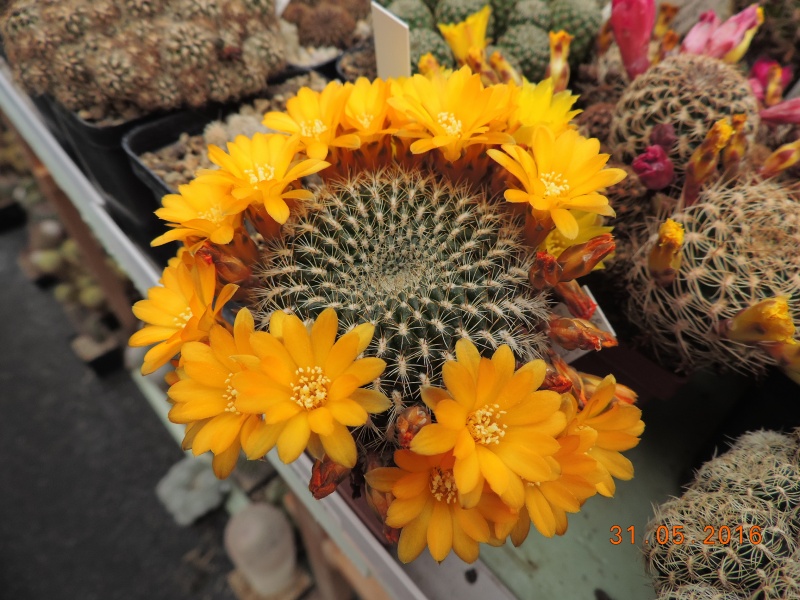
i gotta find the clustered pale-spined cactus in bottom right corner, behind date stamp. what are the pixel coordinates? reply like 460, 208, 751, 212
644, 431, 800, 600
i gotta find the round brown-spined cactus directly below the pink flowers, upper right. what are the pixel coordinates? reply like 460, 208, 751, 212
610, 54, 759, 183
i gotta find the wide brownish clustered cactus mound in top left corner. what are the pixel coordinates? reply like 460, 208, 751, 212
0, 0, 285, 119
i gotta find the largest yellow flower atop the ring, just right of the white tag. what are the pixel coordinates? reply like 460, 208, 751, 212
388, 67, 513, 162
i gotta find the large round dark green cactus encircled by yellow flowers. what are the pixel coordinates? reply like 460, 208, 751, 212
256, 168, 546, 442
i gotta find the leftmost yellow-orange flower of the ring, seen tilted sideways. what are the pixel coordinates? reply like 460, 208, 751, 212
128, 252, 238, 375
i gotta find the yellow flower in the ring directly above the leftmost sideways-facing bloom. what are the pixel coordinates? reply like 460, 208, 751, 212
151, 179, 249, 246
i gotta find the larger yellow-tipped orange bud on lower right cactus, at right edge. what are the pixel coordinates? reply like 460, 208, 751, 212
723, 296, 795, 343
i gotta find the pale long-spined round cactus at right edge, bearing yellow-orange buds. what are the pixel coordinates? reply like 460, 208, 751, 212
627, 177, 800, 373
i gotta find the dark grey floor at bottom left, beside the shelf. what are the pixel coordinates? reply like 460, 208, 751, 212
0, 229, 233, 600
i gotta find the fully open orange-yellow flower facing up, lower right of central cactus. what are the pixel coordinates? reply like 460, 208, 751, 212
411, 339, 566, 508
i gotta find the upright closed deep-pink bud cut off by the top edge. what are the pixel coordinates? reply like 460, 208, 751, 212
610, 0, 656, 80
